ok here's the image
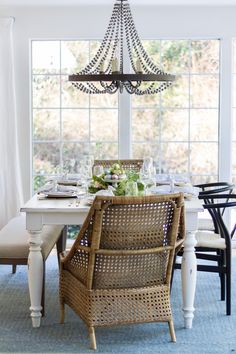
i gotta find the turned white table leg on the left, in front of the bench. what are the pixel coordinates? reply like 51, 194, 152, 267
28, 231, 43, 327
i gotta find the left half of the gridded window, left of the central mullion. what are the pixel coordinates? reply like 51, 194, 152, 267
32, 41, 118, 188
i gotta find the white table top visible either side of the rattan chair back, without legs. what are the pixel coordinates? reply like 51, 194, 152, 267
20, 195, 204, 213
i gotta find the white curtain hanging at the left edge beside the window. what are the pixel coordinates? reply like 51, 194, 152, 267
0, 17, 23, 229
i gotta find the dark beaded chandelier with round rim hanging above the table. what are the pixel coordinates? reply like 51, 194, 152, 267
69, 0, 175, 95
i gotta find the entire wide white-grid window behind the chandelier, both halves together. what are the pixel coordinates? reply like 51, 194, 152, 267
32, 40, 219, 188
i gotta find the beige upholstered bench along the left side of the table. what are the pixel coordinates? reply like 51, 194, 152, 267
0, 215, 66, 315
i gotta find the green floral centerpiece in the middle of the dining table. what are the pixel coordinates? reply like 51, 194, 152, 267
88, 162, 145, 196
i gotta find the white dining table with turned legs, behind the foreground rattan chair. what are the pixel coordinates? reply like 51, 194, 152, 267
21, 195, 203, 328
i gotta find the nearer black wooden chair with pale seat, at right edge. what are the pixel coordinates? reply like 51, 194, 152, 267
175, 194, 236, 315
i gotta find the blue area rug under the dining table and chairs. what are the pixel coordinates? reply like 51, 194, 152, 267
0, 256, 236, 354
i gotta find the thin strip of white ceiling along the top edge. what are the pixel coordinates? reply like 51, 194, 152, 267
0, 0, 236, 6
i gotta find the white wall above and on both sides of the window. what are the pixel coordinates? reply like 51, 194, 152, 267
0, 1, 236, 199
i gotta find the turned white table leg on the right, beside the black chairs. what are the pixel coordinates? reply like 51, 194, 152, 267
181, 231, 197, 328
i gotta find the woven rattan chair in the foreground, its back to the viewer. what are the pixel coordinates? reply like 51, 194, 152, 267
60, 194, 184, 349
